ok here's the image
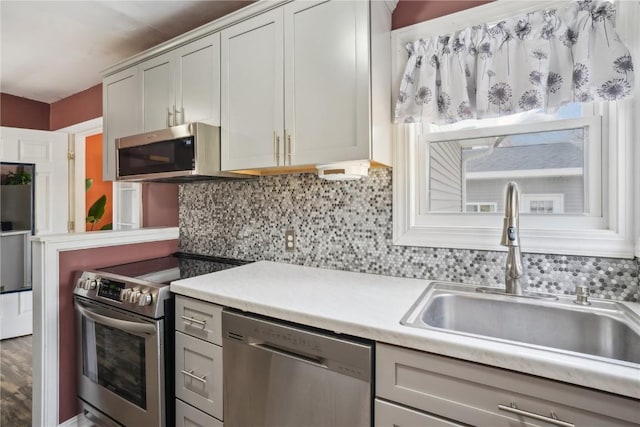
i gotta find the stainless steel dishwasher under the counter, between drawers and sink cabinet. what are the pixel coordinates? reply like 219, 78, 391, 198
222, 311, 373, 427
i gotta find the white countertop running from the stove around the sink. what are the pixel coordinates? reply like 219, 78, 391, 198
171, 261, 640, 398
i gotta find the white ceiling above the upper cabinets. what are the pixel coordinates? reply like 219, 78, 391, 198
0, 0, 251, 103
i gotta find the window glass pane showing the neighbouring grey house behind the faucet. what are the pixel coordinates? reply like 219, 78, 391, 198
425, 126, 589, 215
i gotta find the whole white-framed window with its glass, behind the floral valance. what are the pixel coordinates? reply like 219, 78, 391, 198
392, 0, 640, 258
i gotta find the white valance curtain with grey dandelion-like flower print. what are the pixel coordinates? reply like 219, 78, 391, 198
395, 0, 633, 123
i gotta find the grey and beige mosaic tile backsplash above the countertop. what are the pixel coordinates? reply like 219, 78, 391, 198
179, 169, 640, 302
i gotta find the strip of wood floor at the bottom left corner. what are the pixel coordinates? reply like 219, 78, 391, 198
0, 335, 32, 427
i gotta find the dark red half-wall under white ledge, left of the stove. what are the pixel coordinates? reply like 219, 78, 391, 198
58, 240, 178, 423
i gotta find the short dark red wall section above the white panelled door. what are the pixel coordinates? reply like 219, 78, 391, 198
0, 93, 51, 130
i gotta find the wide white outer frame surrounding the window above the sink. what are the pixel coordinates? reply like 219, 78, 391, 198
392, 0, 640, 258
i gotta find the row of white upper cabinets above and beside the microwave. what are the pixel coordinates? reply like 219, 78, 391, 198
104, 0, 397, 178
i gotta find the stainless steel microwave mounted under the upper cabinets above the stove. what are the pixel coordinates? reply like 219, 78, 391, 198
116, 122, 251, 183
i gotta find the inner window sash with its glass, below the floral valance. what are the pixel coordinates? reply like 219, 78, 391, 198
428, 104, 603, 216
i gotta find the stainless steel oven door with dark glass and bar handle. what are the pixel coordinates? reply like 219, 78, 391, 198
75, 297, 165, 426
